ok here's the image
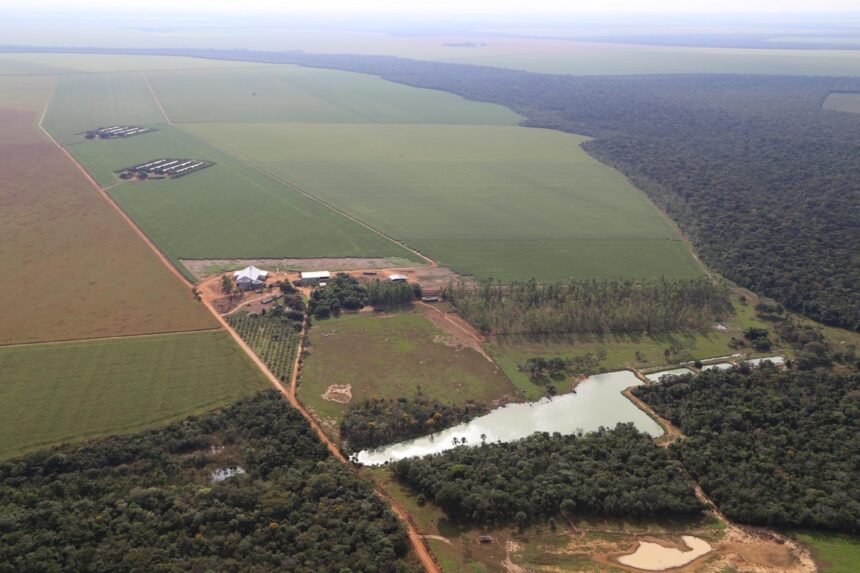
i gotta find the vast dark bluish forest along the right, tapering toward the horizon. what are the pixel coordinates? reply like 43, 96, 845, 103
11, 46, 860, 330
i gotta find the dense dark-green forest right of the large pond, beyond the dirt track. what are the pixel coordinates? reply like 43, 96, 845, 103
635, 368, 860, 533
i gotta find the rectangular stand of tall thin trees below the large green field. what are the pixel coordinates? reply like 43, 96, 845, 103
442, 278, 732, 335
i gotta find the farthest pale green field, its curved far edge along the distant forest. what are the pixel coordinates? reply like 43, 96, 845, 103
146, 65, 523, 125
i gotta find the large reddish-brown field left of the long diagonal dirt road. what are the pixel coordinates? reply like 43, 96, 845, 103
0, 81, 217, 345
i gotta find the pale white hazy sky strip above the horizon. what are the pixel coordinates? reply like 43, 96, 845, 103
10, 0, 859, 14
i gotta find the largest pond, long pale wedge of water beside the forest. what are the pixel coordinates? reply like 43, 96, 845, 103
356, 370, 663, 465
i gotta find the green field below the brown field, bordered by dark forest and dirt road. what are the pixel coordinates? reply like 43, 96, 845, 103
0, 332, 266, 458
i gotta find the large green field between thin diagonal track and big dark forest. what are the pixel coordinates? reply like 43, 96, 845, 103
186, 124, 702, 281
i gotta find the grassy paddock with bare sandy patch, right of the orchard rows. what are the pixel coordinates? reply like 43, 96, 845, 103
299, 310, 514, 422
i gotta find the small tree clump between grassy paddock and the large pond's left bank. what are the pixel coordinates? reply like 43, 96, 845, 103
340, 396, 489, 451
